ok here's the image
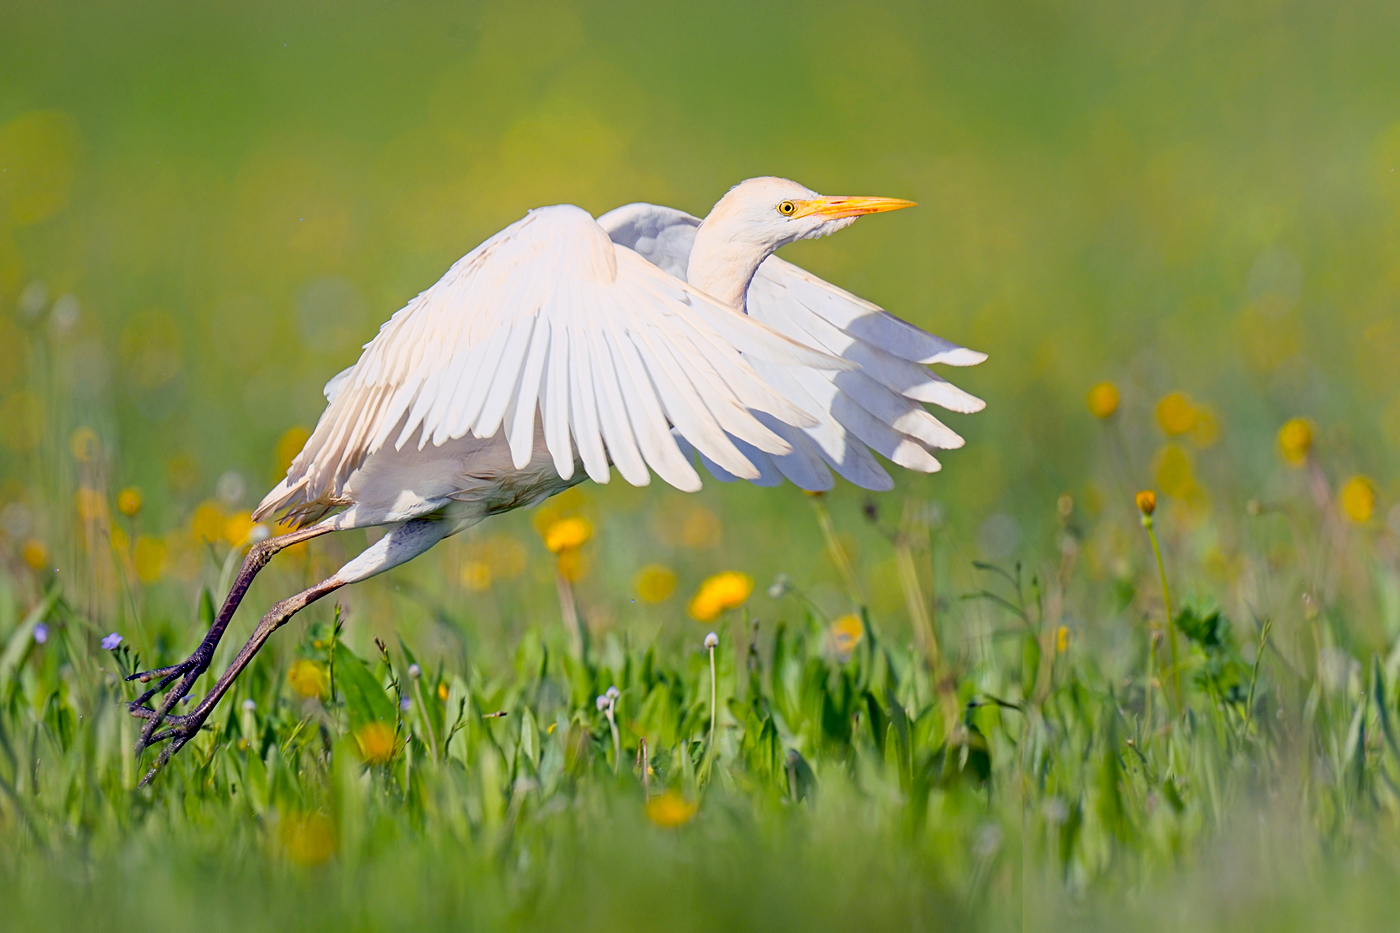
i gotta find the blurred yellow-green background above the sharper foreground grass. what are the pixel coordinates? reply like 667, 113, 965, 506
0, 0, 1400, 647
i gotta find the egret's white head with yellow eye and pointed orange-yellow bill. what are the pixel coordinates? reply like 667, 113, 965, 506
706, 177, 914, 252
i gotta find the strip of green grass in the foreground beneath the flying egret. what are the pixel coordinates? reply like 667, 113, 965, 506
0, 461, 1400, 930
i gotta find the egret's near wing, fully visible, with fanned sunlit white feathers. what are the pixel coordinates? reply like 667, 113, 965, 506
259, 205, 847, 514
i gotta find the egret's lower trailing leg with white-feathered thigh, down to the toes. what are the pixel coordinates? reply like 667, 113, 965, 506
132, 518, 456, 785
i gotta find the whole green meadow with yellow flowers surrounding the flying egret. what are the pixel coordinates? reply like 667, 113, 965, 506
0, 0, 1400, 933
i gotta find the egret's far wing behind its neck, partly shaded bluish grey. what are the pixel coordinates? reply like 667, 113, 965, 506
598, 205, 987, 490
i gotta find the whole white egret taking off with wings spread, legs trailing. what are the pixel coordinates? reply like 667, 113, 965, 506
130, 178, 986, 779
